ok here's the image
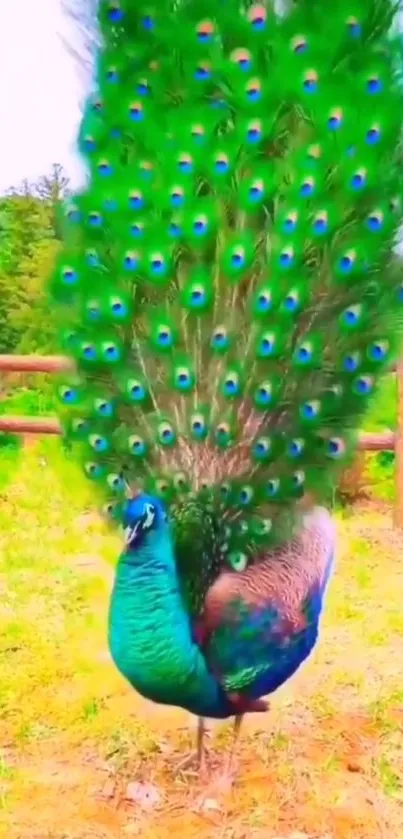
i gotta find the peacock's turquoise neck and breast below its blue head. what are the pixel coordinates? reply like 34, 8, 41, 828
109, 527, 233, 718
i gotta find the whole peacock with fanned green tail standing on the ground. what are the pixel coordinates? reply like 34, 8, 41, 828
50, 0, 403, 780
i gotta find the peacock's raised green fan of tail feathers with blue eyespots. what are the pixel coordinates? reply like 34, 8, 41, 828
52, 0, 403, 567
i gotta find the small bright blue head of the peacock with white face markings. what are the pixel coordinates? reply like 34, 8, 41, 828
123, 493, 167, 551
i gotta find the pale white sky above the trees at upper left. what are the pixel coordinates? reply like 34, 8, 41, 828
0, 0, 85, 194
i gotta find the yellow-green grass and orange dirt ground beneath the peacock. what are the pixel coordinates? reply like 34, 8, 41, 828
0, 440, 403, 839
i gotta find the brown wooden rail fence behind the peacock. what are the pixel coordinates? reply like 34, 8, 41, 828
0, 355, 403, 529
